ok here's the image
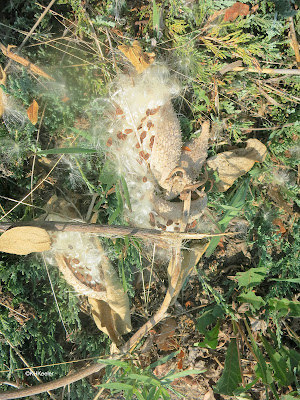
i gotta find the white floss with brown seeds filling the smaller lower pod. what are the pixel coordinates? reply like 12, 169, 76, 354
51, 232, 105, 292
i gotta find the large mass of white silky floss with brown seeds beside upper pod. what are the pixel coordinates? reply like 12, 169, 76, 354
106, 66, 188, 231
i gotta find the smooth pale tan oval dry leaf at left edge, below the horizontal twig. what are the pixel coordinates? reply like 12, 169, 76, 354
0, 226, 50, 255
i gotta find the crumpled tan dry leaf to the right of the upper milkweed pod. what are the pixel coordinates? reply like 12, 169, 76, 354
207, 139, 267, 192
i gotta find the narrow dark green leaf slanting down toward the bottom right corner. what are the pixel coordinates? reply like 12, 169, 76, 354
261, 336, 294, 386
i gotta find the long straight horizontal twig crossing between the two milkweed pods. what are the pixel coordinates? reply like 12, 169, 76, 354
0, 221, 238, 243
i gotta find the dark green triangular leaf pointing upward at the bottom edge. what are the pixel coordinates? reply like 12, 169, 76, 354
214, 338, 242, 396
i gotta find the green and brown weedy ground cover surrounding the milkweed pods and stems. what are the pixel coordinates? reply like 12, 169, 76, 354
0, 0, 300, 400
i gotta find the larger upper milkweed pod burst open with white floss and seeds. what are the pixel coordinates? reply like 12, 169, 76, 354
106, 65, 209, 231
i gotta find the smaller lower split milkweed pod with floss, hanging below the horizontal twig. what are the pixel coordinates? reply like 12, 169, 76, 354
50, 232, 131, 345
